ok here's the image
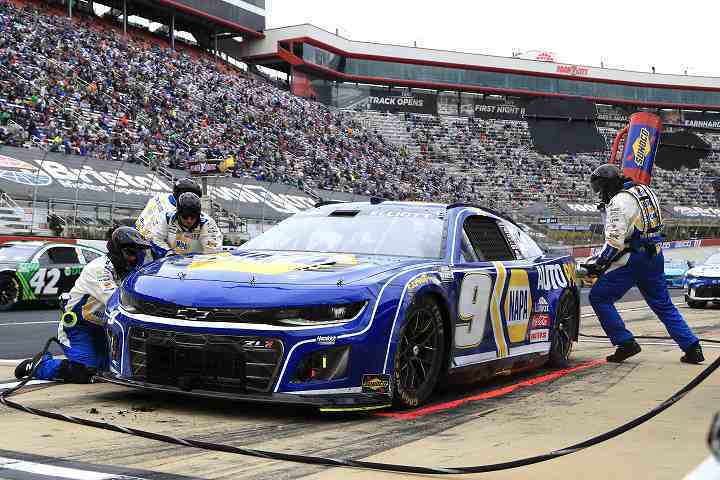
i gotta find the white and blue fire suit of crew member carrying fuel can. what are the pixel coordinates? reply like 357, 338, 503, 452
590, 182, 698, 350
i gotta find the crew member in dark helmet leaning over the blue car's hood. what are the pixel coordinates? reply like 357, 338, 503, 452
151, 192, 222, 258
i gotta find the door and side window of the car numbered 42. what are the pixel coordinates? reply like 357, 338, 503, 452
28, 245, 82, 298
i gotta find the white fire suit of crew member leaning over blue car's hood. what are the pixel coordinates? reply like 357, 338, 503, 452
150, 213, 223, 258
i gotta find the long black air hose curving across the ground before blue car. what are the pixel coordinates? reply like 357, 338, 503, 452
0, 337, 720, 475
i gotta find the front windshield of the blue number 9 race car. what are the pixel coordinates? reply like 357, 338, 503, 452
242, 209, 444, 258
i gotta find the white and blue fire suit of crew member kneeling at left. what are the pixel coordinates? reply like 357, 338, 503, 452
35, 254, 138, 380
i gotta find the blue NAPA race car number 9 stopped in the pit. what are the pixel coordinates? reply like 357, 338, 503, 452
102, 200, 580, 411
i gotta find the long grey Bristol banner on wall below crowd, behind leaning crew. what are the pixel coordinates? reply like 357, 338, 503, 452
0, 147, 367, 219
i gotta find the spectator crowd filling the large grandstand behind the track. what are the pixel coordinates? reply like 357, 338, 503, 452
0, 0, 720, 215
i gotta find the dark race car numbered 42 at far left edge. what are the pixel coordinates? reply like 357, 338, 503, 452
0, 241, 103, 311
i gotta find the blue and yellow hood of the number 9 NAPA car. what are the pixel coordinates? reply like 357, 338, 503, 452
137, 250, 428, 286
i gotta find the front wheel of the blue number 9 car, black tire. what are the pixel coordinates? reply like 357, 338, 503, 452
393, 297, 445, 408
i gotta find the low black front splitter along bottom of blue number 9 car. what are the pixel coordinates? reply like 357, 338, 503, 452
95, 372, 392, 412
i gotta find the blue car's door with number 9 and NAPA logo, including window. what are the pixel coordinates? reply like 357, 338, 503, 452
453, 214, 537, 365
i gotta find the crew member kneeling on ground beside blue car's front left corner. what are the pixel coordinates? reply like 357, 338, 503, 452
15, 227, 150, 383
